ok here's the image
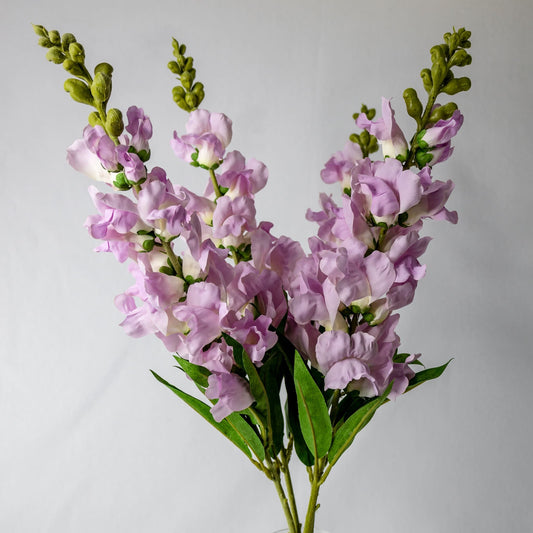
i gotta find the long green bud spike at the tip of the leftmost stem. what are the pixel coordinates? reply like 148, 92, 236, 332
33, 24, 124, 140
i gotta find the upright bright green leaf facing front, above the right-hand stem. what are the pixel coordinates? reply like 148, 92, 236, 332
294, 352, 332, 459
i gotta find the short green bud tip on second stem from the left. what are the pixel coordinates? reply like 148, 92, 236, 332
168, 39, 205, 113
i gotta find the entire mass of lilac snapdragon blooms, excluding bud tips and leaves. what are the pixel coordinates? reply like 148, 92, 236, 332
68, 94, 462, 420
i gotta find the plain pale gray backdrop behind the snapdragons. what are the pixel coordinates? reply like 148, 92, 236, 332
0, 0, 533, 533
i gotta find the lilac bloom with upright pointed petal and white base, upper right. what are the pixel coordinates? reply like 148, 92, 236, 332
355, 98, 409, 161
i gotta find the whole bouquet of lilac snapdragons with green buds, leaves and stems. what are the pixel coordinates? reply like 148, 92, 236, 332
34, 26, 471, 533
